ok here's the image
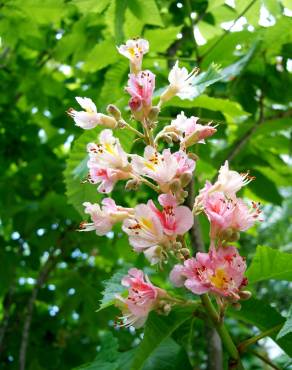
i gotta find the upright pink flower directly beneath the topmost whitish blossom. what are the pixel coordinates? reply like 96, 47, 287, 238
126, 70, 155, 113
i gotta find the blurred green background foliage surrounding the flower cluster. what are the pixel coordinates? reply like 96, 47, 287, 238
0, 0, 292, 370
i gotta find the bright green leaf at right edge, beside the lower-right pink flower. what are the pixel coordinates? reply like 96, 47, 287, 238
246, 246, 292, 284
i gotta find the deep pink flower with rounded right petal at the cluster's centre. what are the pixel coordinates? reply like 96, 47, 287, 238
150, 194, 194, 236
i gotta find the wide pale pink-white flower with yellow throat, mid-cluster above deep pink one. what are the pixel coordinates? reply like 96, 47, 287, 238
132, 146, 195, 192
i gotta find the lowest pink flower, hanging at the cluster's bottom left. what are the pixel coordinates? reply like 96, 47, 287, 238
116, 268, 166, 328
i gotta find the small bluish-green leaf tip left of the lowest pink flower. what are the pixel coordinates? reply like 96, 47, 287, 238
98, 265, 130, 311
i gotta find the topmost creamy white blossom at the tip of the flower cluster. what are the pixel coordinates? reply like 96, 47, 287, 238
117, 38, 149, 74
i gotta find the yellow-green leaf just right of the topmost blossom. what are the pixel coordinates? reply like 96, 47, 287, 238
144, 26, 182, 52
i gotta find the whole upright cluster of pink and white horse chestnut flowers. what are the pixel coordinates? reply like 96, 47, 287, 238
68, 39, 260, 327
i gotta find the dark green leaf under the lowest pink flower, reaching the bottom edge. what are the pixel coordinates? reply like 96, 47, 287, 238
129, 308, 193, 370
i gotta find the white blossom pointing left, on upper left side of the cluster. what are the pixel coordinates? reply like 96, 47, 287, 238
67, 96, 117, 130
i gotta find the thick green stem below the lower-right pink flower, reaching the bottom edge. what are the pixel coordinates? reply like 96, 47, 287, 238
201, 294, 244, 370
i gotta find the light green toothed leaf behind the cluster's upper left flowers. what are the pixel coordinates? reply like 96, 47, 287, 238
64, 127, 134, 216
